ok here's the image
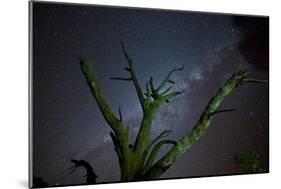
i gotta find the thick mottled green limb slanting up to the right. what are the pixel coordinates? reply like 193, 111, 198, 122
143, 69, 266, 179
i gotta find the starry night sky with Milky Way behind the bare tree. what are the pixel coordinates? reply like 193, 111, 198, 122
33, 2, 269, 185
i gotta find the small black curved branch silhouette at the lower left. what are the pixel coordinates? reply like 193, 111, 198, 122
68, 159, 98, 184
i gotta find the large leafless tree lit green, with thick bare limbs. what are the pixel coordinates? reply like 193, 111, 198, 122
80, 42, 265, 181
